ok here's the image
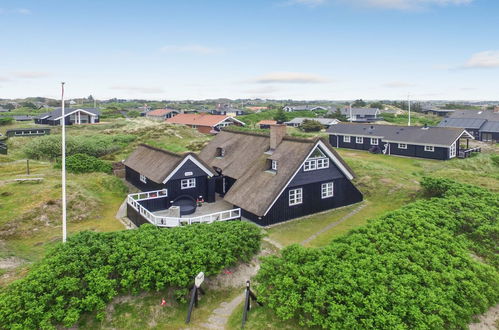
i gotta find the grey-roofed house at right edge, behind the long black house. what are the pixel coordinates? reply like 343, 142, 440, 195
438, 110, 499, 142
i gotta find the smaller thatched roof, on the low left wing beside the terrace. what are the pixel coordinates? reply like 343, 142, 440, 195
125, 144, 215, 183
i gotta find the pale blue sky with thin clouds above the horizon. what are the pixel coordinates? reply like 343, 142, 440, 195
0, 0, 499, 100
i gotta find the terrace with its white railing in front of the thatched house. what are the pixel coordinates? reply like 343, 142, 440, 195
127, 189, 241, 227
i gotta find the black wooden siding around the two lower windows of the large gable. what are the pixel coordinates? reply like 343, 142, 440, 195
241, 178, 363, 226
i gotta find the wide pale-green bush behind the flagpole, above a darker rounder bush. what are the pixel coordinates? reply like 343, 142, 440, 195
24, 134, 135, 160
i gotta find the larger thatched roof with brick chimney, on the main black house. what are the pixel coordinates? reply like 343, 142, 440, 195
199, 131, 352, 216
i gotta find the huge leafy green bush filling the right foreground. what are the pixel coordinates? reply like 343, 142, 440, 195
257, 179, 499, 329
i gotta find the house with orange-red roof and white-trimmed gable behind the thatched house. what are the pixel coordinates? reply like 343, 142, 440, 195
166, 113, 244, 134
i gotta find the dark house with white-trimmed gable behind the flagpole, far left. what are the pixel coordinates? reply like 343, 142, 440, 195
35, 108, 100, 126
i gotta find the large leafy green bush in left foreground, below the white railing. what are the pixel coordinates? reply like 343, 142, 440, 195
0, 222, 260, 329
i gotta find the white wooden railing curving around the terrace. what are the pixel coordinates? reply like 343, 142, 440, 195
127, 189, 241, 227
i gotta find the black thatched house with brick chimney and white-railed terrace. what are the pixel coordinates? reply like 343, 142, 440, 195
125, 125, 363, 226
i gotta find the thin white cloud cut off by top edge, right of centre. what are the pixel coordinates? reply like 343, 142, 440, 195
338, 0, 474, 10
